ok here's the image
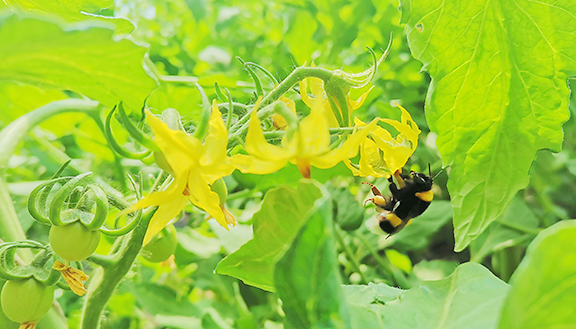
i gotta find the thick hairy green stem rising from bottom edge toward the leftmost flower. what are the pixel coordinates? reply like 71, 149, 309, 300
80, 211, 154, 329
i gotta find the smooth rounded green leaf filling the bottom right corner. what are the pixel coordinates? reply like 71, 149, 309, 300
499, 220, 576, 329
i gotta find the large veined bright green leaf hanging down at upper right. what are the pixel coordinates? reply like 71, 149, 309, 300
401, 0, 576, 251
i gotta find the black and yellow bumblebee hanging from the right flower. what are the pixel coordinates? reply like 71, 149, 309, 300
364, 167, 434, 237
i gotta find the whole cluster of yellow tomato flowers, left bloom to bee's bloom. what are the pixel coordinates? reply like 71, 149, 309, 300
123, 78, 420, 244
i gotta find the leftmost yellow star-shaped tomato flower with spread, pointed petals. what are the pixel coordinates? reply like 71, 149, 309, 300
121, 101, 236, 244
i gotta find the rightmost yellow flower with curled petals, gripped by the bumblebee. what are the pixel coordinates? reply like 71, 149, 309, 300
344, 104, 420, 177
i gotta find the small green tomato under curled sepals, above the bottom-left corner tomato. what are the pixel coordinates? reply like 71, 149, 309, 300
48, 221, 100, 261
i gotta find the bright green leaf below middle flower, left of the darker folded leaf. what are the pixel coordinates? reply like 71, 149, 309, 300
216, 180, 322, 291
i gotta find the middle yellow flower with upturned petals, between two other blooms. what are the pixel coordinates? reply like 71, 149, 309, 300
232, 89, 377, 178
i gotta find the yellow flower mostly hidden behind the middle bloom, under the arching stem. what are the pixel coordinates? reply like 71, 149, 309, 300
300, 72, 374, 128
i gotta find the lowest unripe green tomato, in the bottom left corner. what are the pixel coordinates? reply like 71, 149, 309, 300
2, 278, 54, 323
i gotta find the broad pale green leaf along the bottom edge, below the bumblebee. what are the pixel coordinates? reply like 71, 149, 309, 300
344, 263, 508, 329
